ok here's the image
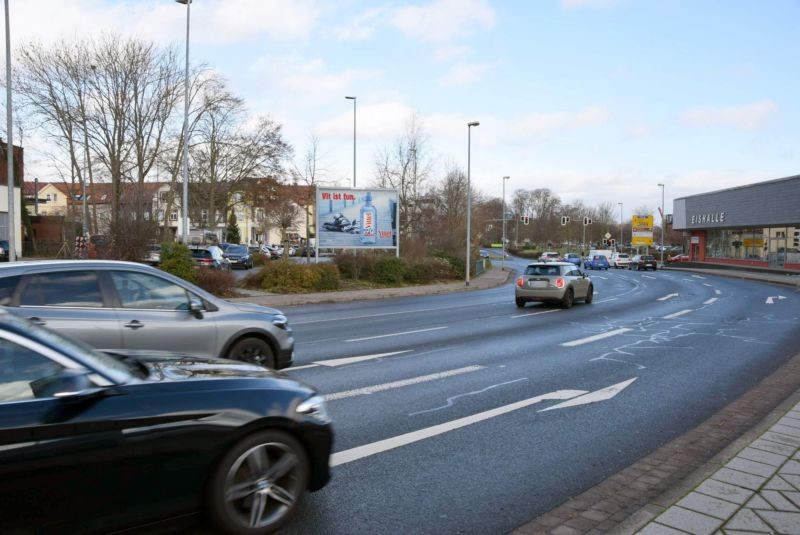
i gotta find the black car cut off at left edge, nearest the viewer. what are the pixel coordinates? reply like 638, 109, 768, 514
0, 310, 333, 533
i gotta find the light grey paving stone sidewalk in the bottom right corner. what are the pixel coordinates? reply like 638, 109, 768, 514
638, 403, 800, 535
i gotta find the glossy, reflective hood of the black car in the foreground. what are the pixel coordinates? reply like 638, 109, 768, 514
107, 350, 284, 381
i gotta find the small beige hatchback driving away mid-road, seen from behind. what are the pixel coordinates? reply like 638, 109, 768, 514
514, 261, 594, 308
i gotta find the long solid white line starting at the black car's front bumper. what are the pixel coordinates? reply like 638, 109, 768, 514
330, 390, 587, 467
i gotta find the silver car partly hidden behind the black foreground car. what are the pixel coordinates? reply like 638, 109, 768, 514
0, 260, 294, 369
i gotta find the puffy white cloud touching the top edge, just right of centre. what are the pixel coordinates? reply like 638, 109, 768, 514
392, 0, 495, 42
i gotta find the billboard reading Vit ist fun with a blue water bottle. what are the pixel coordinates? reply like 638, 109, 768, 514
316, 187, 399, 249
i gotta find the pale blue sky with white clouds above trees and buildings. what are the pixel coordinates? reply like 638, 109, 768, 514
4, 0, 800, 219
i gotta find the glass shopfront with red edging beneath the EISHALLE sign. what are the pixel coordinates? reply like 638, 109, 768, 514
706, 227, 800, 266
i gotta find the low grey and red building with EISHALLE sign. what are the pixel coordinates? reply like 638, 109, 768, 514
673, 175, 800, 271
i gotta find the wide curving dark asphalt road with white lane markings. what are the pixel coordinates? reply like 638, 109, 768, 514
276, 261, 800, 534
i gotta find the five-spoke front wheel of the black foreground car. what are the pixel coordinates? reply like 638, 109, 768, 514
207, 431, 309, 534
